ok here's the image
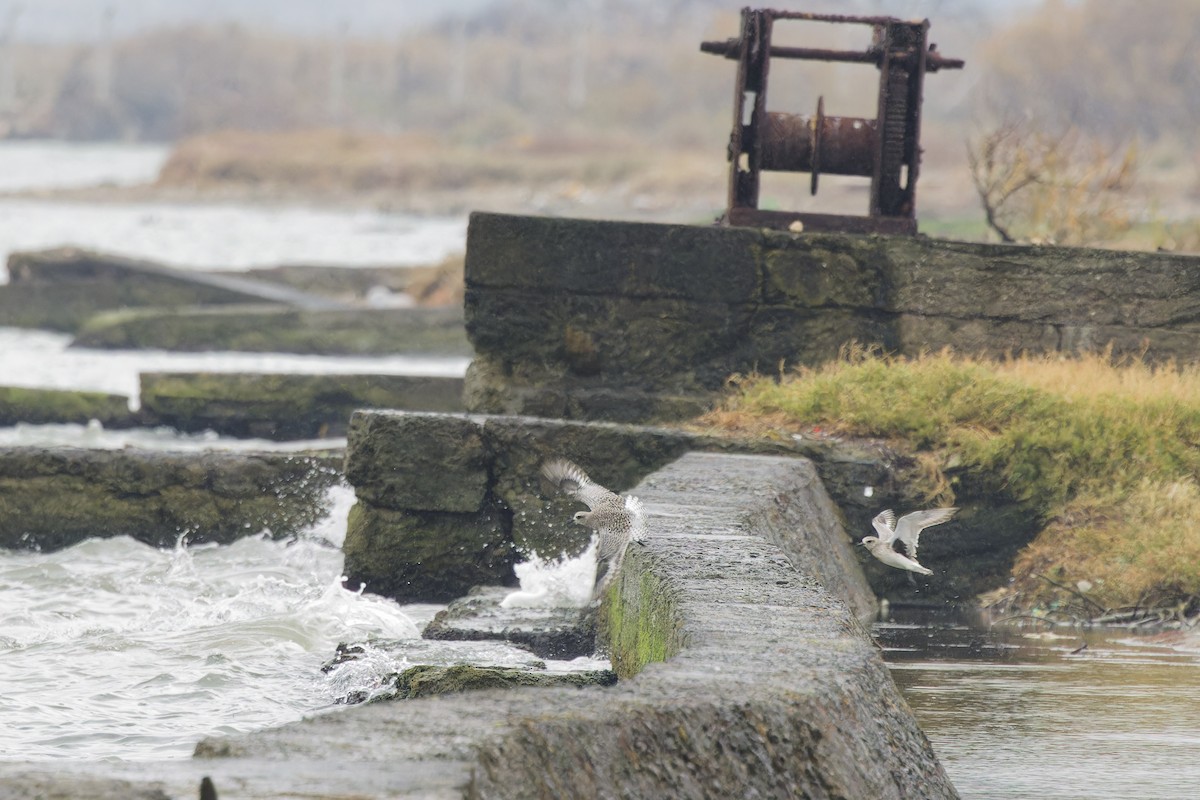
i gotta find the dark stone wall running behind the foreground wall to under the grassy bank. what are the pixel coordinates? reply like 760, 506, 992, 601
343, 410, 1038, 602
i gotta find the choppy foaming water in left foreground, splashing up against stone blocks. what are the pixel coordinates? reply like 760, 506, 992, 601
0, 488, 419, 760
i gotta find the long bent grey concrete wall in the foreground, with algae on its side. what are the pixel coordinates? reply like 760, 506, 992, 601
148, 453, 956, 800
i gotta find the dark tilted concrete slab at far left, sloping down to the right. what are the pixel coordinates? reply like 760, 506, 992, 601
0, 247, 341, 331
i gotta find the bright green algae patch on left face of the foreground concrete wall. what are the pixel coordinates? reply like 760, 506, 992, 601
600, 552, 684, 679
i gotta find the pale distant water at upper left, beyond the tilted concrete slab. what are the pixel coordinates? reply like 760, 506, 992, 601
0, 142, 467, 282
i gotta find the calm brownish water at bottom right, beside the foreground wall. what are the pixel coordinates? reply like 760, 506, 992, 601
876, 609, 1200, 800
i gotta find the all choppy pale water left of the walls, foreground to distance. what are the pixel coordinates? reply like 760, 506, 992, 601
0, 143, 506, 762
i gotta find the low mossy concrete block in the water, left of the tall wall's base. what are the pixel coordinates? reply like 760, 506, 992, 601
140, 372, 462, 440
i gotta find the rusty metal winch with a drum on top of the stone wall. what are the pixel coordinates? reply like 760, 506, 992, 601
700, 8, 962, 234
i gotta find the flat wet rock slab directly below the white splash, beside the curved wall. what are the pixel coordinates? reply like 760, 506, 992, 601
421, 587, 596, 661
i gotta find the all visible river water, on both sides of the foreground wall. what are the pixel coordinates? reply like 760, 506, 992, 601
0, 143, 1200, 800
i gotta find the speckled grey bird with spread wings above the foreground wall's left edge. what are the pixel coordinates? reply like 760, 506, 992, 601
541, 458, 646, 602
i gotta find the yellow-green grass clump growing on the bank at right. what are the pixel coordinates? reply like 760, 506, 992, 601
703, 349, 1200, 608
